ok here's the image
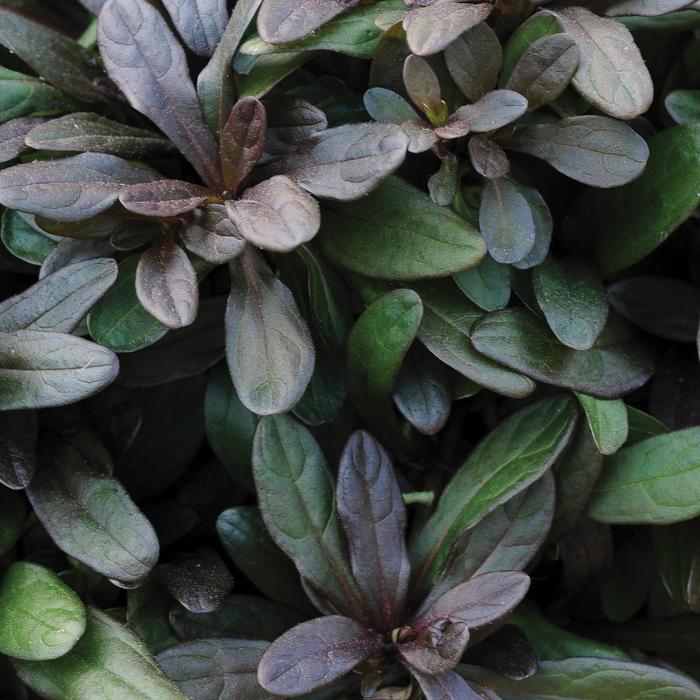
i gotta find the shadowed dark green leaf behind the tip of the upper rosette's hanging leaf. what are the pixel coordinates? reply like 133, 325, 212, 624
204, 365, 257, 493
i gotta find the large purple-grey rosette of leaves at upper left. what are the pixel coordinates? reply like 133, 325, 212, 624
0, 0, 407, 414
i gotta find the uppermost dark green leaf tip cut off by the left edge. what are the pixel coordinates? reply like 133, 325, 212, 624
0, 66, 76, 123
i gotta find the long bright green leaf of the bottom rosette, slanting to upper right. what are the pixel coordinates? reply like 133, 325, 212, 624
410, 396, 576, 586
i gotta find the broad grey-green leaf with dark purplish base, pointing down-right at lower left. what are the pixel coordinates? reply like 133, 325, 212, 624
27, 442, 159, 585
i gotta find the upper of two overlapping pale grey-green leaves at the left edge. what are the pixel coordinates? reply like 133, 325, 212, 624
0, 258, 117, 333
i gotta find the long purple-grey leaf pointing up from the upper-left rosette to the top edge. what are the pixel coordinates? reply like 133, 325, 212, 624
98, 0, 223, 189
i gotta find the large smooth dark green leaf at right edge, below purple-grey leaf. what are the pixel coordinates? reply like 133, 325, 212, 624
572, 126, 700, 277
